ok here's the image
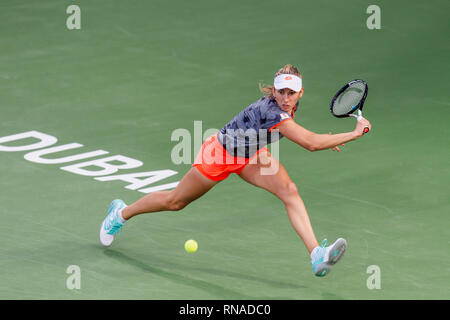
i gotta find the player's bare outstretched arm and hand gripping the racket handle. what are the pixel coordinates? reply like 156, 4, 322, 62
277, 119, 370, 151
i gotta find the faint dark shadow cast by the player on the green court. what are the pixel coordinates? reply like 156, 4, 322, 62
104, 249, 306, 300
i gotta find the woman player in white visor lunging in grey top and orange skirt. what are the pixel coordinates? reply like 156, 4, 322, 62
100, 65, 371, 277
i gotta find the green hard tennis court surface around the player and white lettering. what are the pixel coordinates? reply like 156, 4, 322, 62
0, 0, 450, 300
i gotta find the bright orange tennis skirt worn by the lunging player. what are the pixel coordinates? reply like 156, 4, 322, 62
192, 134, 269, 181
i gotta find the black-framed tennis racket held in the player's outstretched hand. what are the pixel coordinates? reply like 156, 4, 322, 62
330, 79, 369, 133
